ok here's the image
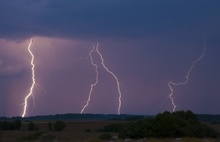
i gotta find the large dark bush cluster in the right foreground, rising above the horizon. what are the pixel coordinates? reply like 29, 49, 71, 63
104, 111, 220, 139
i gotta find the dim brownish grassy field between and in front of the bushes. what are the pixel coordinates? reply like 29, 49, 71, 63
0, 121, 220, 142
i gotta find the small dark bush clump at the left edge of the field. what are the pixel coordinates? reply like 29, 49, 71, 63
0, 119, 21, 130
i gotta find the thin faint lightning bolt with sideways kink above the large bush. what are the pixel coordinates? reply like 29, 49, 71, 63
168, 28, 215, 112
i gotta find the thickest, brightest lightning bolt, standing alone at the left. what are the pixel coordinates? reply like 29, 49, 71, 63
22, 39, 36, 117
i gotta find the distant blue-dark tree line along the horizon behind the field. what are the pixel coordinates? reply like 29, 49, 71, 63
0, 113, 220, 123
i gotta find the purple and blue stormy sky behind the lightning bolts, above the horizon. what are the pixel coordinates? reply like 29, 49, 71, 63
0, 0, 220, 116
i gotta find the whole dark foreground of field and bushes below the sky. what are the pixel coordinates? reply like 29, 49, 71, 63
0, 111, 220, 142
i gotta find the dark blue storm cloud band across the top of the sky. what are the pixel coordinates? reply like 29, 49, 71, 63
0, 0, 220, 38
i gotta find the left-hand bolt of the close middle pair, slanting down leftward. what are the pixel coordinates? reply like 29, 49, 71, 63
81, 45, 99, 114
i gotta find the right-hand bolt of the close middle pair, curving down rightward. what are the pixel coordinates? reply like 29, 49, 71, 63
96, 43, 122, 114
